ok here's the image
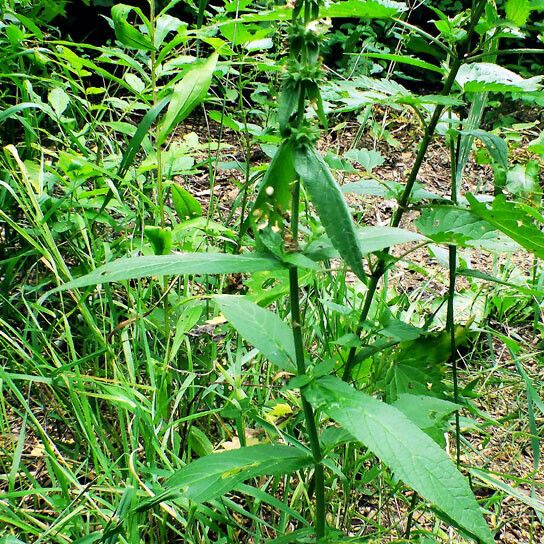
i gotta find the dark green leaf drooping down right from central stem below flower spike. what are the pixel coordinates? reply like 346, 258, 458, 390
295, 147, 366, 281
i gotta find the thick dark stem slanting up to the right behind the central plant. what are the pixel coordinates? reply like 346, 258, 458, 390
342, 0, 486, 381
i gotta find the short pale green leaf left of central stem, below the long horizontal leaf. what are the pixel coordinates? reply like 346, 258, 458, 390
214, 295, 295, 371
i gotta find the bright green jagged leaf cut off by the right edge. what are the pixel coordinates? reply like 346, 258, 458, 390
466, 193, 544, 259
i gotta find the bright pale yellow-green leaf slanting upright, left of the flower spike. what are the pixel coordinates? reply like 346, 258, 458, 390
157, 53, 219, 145
